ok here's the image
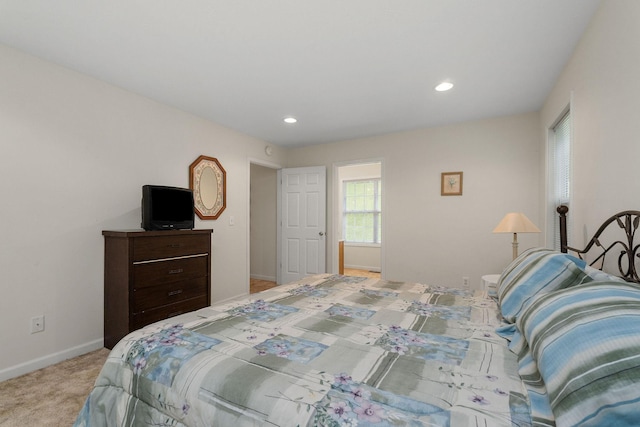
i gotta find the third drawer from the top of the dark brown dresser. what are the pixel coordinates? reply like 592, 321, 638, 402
132, 277, 207, 312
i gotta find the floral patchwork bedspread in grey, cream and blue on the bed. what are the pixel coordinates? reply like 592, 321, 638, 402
76, 274, 531, 427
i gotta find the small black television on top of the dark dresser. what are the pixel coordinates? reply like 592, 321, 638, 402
141, 185, 195, 231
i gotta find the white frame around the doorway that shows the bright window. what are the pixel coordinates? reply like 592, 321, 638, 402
327, 157, 387, 279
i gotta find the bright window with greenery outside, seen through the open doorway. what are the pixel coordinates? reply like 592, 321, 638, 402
342, 179, 382, 244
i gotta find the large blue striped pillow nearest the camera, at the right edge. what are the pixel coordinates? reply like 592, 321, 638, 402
516, 281, 640, 426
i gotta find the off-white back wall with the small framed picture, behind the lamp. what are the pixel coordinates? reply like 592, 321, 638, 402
287, 113, 541, 287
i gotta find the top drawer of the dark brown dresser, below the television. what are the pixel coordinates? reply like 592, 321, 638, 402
133, 231, 211, 262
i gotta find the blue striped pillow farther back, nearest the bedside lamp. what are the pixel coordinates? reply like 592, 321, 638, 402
497, 248, 593, 323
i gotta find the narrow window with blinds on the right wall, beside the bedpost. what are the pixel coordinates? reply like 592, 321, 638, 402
549, 111, 572, 250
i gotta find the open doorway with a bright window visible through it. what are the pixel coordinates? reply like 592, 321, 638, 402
334, 160, 384, 277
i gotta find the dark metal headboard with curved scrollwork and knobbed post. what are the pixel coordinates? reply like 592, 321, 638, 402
556, 205, 640, 283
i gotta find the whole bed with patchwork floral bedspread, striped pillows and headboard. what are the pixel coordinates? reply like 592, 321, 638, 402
75, 206, 640, 427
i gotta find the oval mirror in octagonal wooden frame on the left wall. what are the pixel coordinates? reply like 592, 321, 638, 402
189, 156, 227, 219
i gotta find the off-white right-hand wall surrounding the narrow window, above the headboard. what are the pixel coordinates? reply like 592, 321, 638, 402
541, 0, 640, 251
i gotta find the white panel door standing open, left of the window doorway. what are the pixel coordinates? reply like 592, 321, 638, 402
278, 166, 327, 283
